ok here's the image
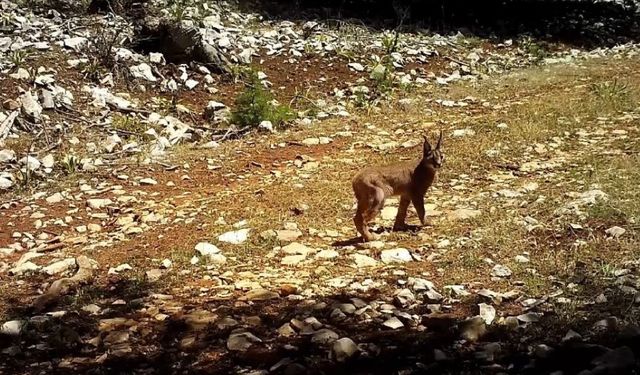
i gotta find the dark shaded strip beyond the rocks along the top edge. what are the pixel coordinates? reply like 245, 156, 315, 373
239, 0, 640, 47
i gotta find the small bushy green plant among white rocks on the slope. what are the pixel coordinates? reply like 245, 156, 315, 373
231, 72, 295, 127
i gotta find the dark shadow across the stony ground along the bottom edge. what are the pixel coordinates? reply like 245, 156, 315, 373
0, 277, 640, 375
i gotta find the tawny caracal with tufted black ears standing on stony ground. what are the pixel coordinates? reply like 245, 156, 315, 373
352, 132, 444, 242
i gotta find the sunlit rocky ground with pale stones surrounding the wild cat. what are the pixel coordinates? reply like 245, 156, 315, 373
0, 0, 640, 375
